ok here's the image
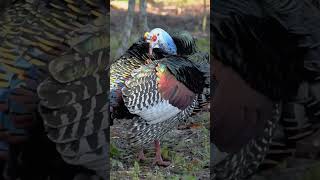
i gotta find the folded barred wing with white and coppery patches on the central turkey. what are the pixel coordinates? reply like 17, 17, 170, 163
122, 56, 204, 146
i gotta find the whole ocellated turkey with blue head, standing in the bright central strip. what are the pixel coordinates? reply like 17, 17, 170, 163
110, 28, 210, 166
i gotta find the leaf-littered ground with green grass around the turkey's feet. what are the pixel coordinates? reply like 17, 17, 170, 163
110, 112, 210, 180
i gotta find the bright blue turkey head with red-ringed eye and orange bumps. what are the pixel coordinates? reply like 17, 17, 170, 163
144, 28, 177, 55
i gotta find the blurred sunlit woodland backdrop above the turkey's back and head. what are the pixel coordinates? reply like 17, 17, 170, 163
110, 0, 210, 58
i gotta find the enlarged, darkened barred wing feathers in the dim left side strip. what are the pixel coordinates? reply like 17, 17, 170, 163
38, 20, 109, 179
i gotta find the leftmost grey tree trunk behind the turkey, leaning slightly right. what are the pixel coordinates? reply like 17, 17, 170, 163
116, 0, 136, 57
